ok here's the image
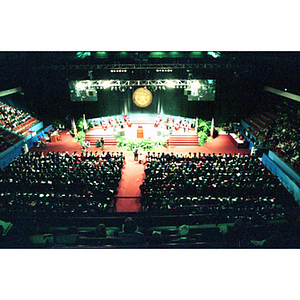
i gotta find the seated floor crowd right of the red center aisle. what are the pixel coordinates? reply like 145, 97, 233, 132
140, 153, 294, 221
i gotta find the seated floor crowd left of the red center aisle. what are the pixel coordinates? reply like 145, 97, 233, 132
0, 151, 124, 213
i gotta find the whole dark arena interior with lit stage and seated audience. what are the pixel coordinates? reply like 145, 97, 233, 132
0, 51, 300, 250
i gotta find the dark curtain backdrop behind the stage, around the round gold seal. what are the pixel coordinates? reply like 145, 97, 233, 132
70, 88, 215, 119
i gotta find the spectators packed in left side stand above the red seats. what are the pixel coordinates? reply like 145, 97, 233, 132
0, 102, 32, 130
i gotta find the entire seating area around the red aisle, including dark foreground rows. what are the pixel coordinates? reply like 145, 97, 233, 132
0, 152, 300, 249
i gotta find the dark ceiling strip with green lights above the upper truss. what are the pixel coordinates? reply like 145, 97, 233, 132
0, 51, 300, 68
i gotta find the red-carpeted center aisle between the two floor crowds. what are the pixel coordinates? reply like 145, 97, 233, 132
116, 153, 145, 212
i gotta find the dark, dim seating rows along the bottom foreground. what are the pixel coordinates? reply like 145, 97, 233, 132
7, 215, 300, 249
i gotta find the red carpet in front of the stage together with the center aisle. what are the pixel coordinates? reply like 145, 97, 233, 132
30, 131, 250, 212
